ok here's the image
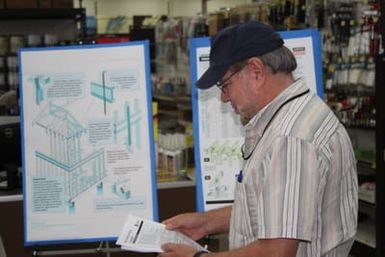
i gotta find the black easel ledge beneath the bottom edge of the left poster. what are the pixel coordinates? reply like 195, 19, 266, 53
32, 241, 123, 257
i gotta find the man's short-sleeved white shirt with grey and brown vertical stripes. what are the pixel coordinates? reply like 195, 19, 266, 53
229, 80, 358, 257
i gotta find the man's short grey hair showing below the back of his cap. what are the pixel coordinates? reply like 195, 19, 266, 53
258, 46, 297, 74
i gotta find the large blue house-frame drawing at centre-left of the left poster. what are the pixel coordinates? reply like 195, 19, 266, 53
34, 103, 107, 210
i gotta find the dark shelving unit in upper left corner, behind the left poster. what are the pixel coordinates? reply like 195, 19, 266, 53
0, 8, 86, 115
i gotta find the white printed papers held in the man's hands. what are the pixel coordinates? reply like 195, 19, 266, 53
116, 214, 206, 252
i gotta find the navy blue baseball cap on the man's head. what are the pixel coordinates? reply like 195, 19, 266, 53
196, 21, 284, 89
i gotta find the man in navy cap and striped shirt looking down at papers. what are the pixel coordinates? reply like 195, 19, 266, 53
160, 21, 358, 257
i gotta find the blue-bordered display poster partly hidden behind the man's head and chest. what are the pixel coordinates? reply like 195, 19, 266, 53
190, 29, 323, 211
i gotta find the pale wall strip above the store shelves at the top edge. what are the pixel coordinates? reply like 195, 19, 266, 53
74, 0, 252, 17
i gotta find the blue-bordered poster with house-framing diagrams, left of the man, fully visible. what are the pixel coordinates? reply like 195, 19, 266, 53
19, 41, 158, 245
